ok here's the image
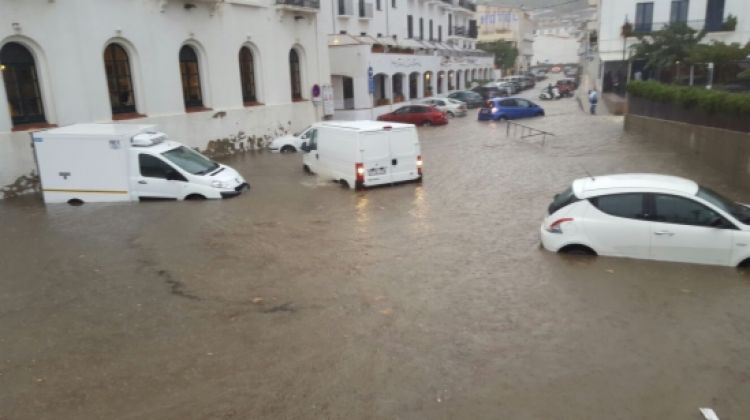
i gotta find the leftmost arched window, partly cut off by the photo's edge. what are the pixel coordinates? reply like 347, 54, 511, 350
0, 42, 47, 126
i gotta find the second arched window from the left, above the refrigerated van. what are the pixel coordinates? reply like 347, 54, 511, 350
104, 44, 135, 114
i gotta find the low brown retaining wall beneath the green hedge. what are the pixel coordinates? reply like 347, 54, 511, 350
625, 114, 750, 188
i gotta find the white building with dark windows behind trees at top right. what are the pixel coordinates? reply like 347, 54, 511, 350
594, 0, 750, 91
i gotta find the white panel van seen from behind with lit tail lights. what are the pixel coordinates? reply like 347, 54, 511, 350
301, 121, 422, 189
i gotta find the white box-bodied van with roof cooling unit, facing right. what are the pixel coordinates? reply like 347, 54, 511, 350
31, 124, 249, 204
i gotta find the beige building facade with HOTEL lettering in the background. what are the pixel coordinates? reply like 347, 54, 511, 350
477, 4, 536, 72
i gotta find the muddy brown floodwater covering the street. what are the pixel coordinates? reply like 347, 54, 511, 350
0, 86, 750, 420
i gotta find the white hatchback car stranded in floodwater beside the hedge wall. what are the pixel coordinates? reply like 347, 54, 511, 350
541, 174, 750, 267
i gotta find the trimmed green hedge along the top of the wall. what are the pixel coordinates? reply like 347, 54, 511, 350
628, 81, 750, 115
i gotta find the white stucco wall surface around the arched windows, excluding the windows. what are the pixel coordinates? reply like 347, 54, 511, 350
0, 0, 330, 194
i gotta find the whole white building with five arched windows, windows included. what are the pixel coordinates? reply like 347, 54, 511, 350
0, 0, 330, 194
